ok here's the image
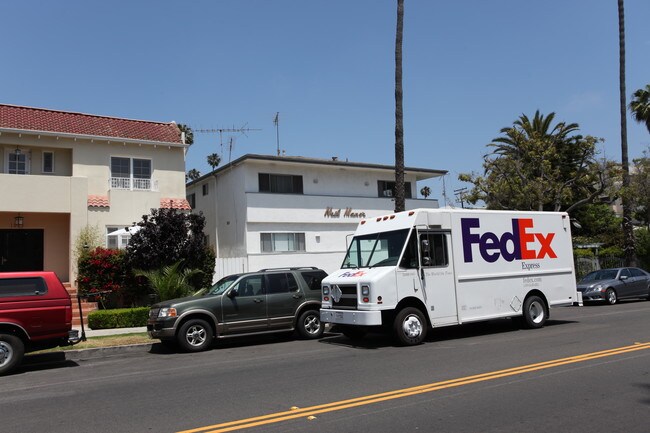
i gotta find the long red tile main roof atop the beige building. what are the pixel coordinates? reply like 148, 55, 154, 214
0, 104, 182, 144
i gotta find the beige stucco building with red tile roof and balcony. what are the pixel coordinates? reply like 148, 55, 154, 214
0, 104, 189, 282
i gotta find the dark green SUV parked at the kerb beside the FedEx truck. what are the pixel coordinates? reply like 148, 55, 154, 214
147, 268, 327, 352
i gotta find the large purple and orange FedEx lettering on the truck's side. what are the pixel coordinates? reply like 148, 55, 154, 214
460, 218, 557, 263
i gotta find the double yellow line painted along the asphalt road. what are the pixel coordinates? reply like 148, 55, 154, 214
178, 343, 650, 433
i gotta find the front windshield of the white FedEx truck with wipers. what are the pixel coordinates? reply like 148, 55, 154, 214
341, 229, 408, 269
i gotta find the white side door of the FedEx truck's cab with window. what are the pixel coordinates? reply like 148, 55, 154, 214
418, 230, 458, 326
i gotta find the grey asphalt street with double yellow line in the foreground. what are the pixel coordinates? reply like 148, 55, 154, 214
0, 301, 650, 433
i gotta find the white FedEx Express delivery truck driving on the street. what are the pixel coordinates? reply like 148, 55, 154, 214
320, 209, 582, 345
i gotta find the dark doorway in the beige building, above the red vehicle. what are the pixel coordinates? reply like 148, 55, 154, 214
0, 229, 44, 272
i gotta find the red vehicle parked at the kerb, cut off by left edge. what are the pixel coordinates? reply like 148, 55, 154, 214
0, 272, 80, 375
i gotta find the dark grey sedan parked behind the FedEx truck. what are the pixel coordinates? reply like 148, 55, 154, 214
578, 268, 650, 305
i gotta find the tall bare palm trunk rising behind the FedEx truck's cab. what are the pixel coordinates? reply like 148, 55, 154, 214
395, 0, 406, 212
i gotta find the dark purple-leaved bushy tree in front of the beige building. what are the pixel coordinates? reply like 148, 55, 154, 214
126, 209, 215, 289
